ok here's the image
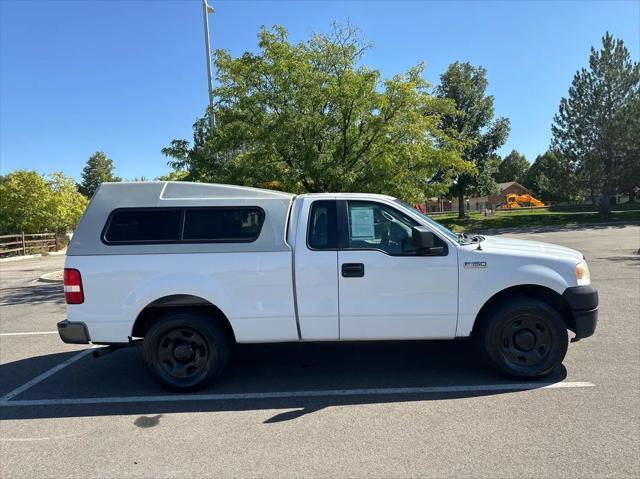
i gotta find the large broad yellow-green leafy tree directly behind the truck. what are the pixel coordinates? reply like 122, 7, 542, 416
162, 26, 466, 200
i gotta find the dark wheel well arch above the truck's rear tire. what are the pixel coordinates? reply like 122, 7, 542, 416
131, 294, 236, 342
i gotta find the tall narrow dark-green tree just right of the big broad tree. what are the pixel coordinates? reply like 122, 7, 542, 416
436, 62, 509, 218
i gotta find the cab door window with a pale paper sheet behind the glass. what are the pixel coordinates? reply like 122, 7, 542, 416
347, 201, 418, 255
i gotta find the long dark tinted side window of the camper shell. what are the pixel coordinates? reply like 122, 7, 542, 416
102, 207, 264, 245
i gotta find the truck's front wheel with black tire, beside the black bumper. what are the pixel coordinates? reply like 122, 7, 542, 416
474, 298, 569, 378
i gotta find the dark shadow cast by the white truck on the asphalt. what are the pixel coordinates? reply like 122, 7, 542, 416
0, 341, 566, 423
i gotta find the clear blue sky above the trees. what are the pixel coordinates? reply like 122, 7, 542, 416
0, 0, 640, 179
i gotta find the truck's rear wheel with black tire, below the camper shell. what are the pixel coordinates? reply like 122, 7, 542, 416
142, 310, 229, 392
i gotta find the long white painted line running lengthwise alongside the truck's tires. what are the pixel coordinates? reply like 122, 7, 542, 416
0, 380, 595, 407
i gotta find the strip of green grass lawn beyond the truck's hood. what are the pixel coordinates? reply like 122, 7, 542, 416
432, 206, 640, 233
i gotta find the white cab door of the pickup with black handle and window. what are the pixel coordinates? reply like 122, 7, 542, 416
338, 201, 458, 340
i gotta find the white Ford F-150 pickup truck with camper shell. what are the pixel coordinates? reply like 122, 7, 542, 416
58, 182, 598, 391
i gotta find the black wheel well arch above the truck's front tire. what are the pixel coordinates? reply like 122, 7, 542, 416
471, 284, 573, 336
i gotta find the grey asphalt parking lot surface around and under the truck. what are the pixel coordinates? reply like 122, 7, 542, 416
0, 226, 640, 478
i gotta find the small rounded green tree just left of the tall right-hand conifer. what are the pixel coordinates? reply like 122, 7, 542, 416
522, 151, 576, 201
